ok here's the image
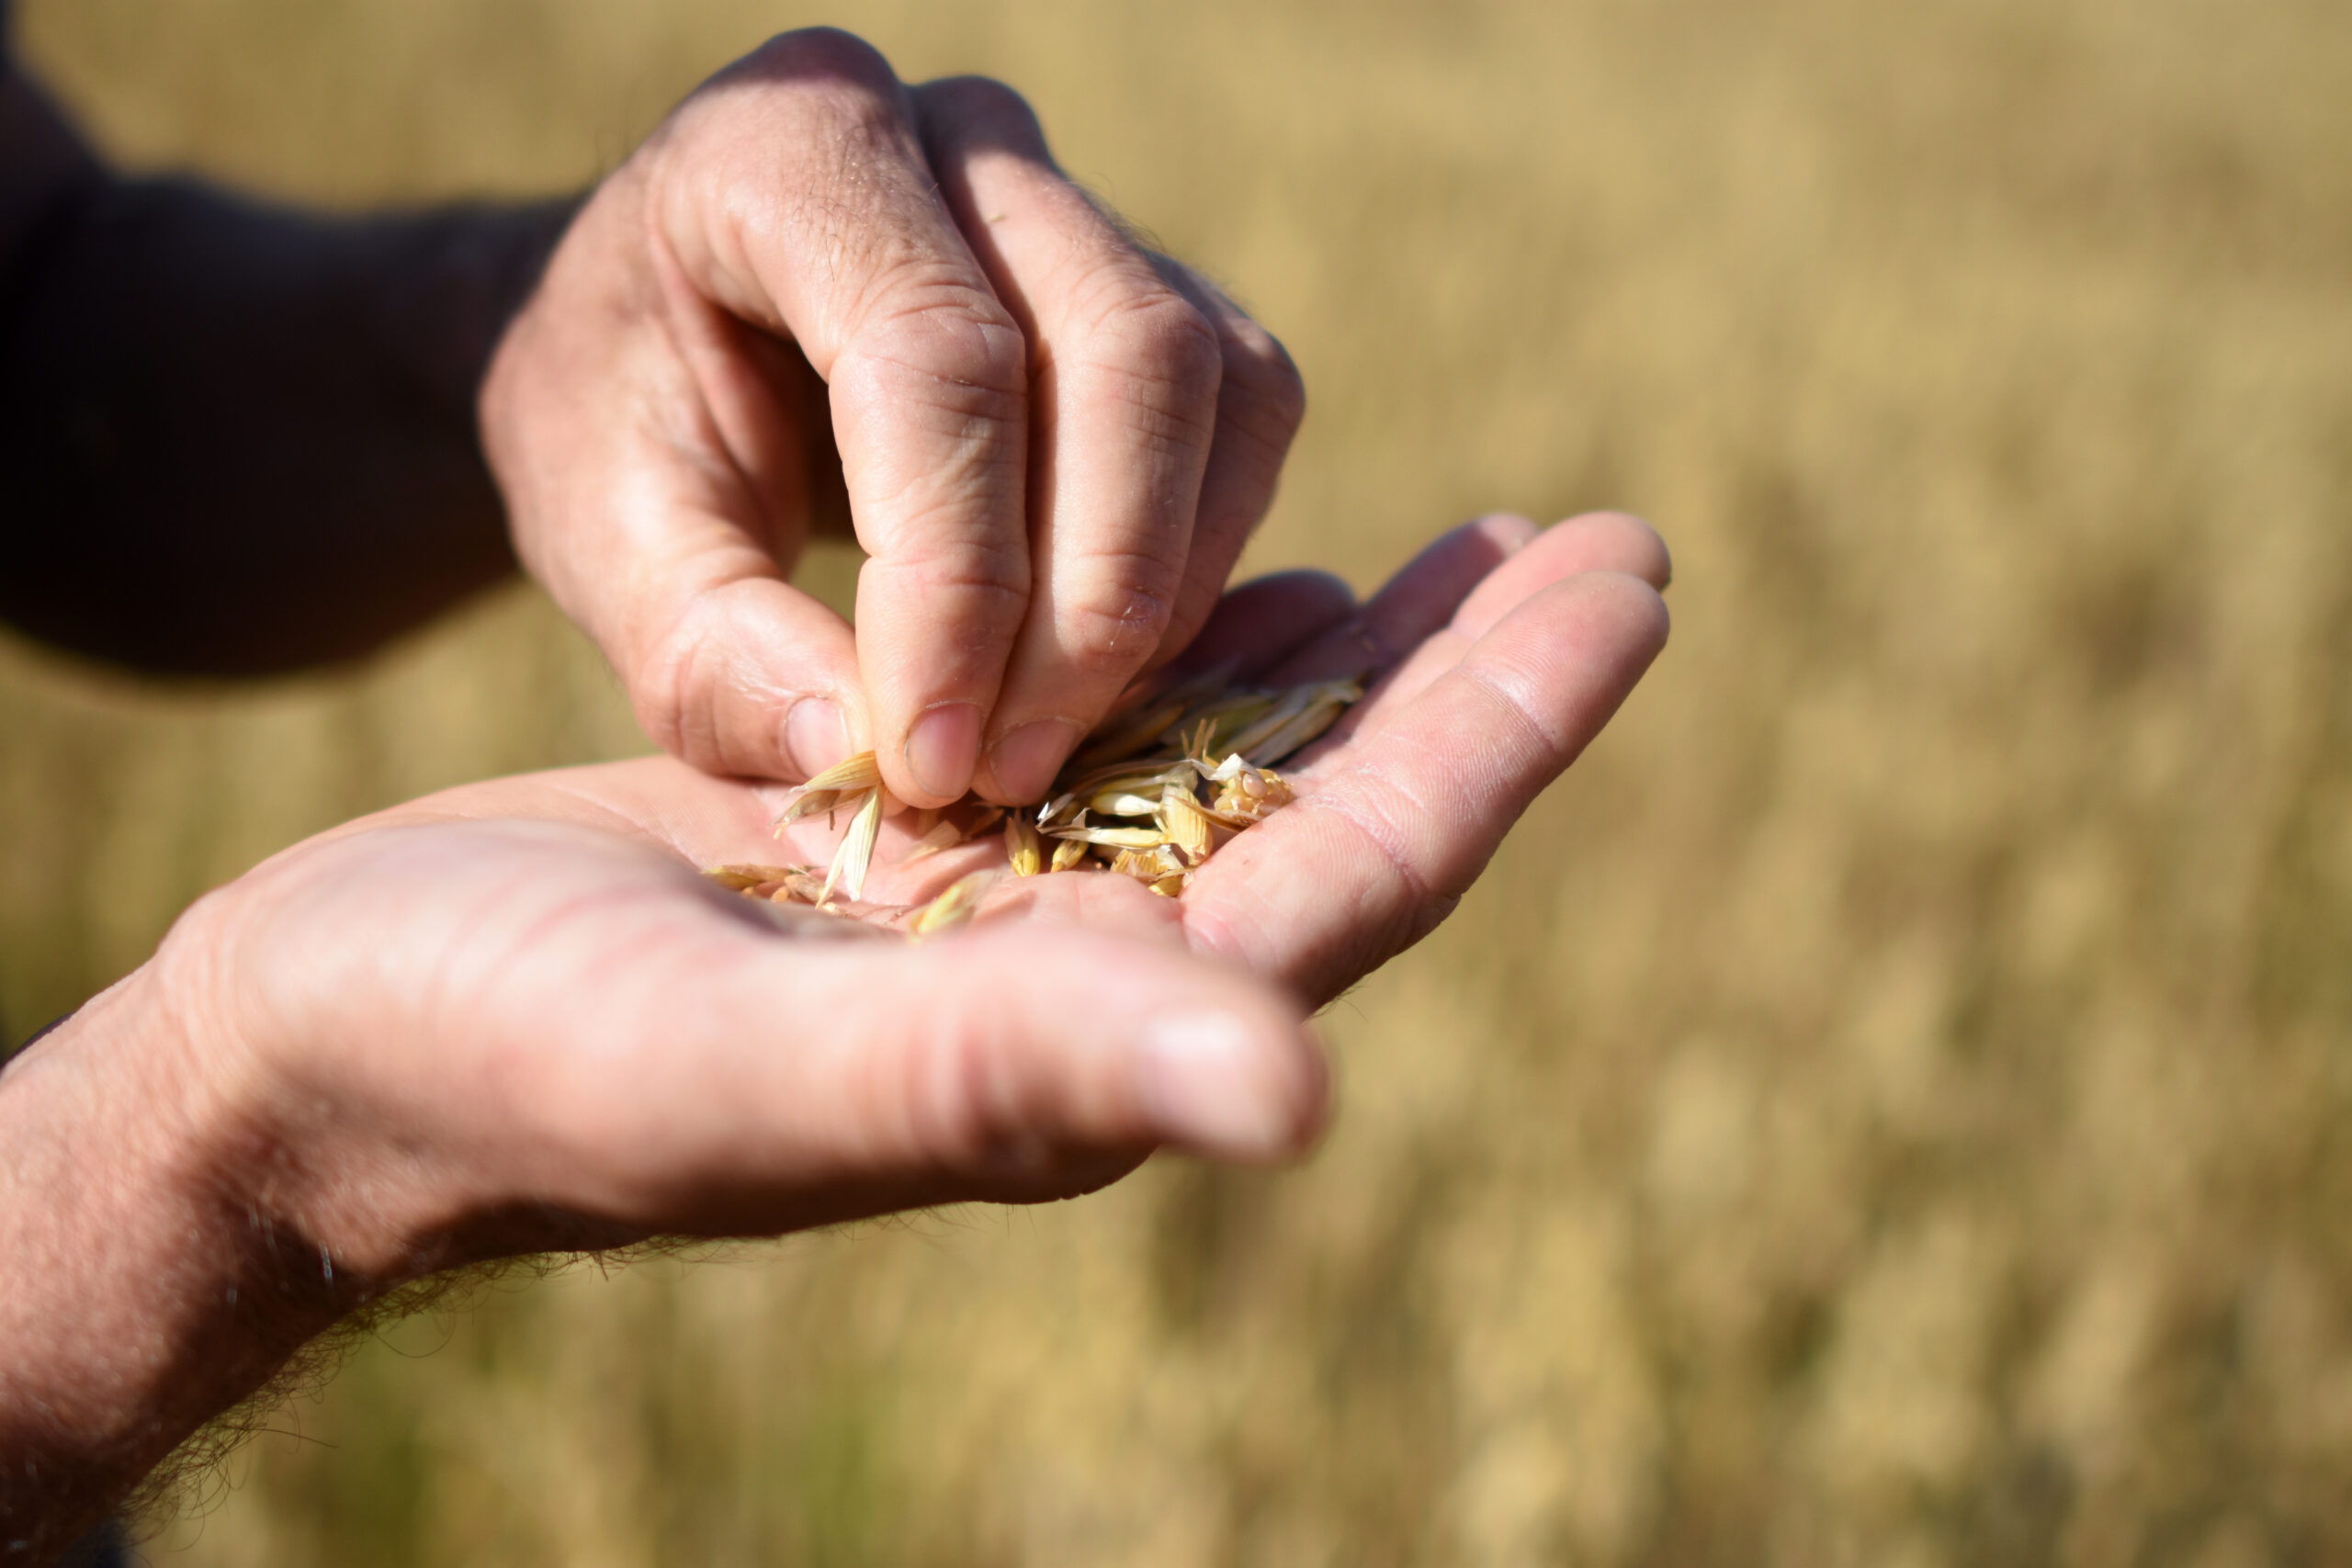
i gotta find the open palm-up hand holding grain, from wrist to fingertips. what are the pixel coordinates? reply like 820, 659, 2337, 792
158, 514, 1665, 1279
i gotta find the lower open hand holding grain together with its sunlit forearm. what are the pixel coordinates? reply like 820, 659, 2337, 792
0, 514, 1668, 1561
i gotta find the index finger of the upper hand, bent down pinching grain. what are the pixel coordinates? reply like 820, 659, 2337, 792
656, 28, 1030, 807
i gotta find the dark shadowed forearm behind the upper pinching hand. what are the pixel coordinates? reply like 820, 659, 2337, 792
0, 176, 564, 674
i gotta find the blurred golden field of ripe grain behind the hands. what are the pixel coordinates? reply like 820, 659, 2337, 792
0, 0, 2352, 1568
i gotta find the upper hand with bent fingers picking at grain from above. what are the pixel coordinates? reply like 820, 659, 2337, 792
482, 30, 1303, 807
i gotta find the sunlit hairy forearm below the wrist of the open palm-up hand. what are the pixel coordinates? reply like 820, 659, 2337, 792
0, 968, 347, 1563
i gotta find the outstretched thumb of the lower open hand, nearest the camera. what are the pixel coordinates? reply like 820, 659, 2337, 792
538, 924, 1329, 1232
